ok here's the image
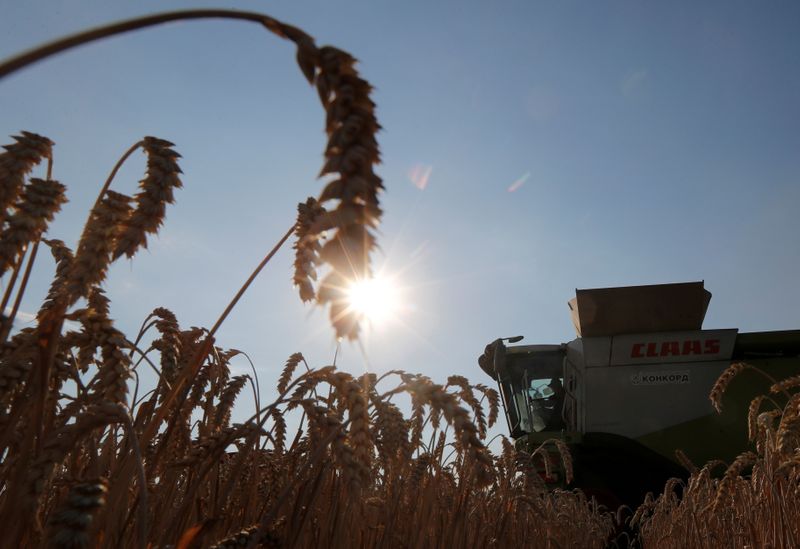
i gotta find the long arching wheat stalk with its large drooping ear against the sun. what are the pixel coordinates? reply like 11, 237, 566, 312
0, 9, 384, 339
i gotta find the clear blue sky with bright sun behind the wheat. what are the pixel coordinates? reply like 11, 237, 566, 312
0, 0, 800, 420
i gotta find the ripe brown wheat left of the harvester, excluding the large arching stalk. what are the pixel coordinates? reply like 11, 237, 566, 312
0, 132, 614, 547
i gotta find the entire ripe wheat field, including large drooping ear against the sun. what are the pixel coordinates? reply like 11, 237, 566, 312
0, 10, 800, 548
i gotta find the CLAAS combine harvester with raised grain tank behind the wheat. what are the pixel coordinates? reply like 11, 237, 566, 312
479, 282, 800, 508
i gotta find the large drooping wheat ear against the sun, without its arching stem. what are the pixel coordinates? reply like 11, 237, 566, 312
297, 41, 383, 339
